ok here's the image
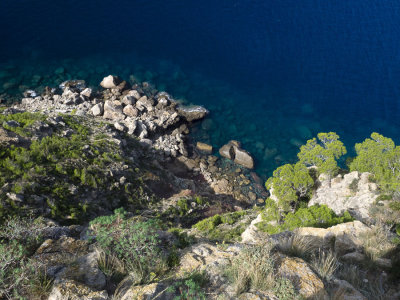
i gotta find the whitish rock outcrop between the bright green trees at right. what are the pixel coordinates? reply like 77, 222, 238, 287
308, 171, 378, 220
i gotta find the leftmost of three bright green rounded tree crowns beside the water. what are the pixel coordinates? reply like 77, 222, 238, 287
265, 162, 314, 211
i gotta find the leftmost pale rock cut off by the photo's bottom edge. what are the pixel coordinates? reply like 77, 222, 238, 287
48, 280, 108, 300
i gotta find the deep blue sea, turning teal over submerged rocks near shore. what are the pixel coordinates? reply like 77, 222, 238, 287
0, 0, 400, 175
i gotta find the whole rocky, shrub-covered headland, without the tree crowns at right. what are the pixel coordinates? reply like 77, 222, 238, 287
0, 75, 400, 300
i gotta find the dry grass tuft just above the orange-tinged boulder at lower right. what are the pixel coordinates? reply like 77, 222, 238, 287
277, 234, 318, 259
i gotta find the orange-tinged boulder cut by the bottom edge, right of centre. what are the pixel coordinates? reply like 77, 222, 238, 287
278, 257, 329, 299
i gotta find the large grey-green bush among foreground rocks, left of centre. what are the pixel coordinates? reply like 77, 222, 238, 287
90, 211, 167, 283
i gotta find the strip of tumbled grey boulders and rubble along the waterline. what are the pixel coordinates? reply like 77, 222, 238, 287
12, 75, 267, 203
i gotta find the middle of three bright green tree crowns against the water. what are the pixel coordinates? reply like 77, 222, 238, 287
297, 132, 347, 176
